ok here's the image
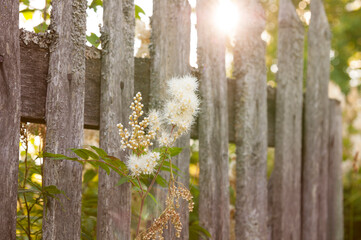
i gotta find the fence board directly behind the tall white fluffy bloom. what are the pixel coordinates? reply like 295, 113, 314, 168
150, 0, 191, 239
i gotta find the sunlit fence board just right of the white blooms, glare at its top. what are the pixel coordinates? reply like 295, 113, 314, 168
196, 0, 230, 239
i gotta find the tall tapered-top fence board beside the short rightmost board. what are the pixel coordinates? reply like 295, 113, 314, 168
302, 0, 330, 240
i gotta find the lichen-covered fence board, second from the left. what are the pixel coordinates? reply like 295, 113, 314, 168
43, 0, 87, 240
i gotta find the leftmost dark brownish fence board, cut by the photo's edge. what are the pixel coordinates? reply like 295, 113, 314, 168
0, 0, 20, 240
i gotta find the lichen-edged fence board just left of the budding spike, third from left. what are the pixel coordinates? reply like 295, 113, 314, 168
97, 0, 135, 240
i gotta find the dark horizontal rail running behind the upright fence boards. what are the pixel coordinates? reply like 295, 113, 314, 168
20, 35, 276, 147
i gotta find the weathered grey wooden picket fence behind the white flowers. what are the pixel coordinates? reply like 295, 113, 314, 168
0, 0, 343, 240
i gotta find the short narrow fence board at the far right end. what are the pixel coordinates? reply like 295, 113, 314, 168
327, 100, 343, 240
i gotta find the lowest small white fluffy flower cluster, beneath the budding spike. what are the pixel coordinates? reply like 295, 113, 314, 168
127, 152, 160, 177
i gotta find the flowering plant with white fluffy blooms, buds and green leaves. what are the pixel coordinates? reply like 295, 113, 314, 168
45, 76, 199, 240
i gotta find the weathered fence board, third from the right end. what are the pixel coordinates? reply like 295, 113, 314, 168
268, 0, 304, 240
